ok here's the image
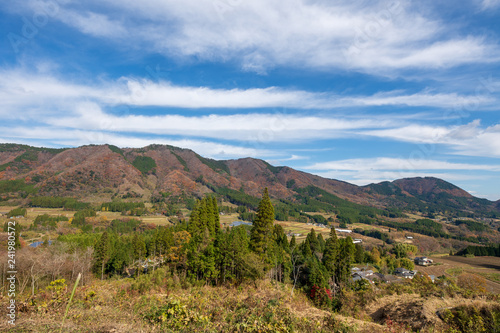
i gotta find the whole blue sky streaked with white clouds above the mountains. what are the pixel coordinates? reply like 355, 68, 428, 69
0, 0, 500, 200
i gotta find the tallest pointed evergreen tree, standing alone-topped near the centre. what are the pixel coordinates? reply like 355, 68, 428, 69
250, 187, 274, 254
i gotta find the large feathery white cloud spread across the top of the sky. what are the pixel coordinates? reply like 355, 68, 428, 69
14, 0, 500, 73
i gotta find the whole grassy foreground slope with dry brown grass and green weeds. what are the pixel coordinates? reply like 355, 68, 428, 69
0, 268, 500, 333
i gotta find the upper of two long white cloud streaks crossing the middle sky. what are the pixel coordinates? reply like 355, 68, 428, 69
0, 66, 497, 113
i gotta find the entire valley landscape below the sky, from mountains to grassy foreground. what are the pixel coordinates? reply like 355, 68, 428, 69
0, 145, 500, 332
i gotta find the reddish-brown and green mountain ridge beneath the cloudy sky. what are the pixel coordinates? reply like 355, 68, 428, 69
0, 144, 500, 215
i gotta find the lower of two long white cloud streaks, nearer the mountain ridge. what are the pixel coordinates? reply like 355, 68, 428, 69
45, 103, 397, 144
